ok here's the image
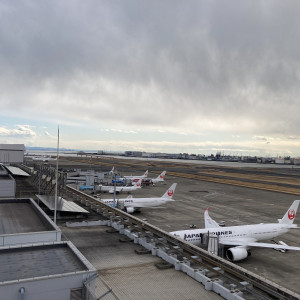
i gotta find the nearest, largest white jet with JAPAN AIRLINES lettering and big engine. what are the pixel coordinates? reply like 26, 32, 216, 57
170, 200, 300, 261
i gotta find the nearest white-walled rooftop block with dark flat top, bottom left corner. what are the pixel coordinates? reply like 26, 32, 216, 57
0, 241, 97, 300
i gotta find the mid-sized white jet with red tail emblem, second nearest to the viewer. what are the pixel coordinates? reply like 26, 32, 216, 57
101, 183, 177, 213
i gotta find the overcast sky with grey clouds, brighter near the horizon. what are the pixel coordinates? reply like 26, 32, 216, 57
0, 0, 300, 156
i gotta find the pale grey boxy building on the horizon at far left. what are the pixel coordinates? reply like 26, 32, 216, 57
0, 144, 25, 164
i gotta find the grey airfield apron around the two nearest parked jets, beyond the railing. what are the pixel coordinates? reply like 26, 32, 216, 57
113, 176, 300, 293
